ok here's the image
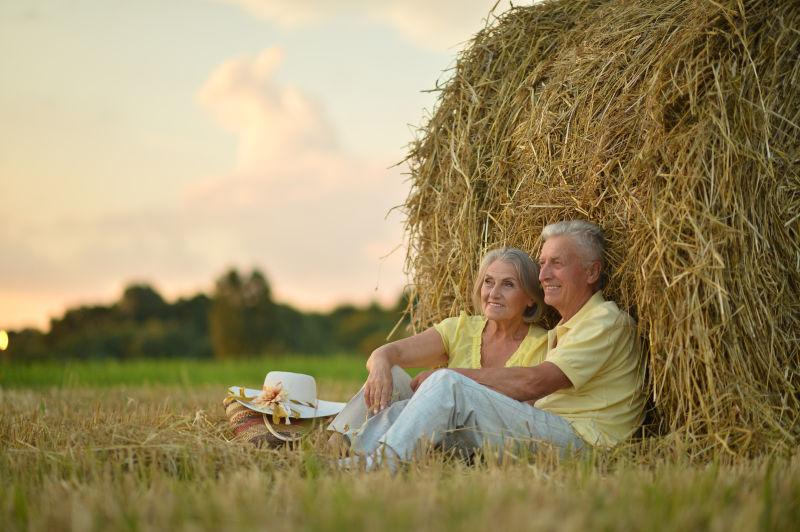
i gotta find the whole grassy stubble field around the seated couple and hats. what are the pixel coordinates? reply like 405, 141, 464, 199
0, 357, 800, 531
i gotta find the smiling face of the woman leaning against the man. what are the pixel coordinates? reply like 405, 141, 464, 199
481, 260, 533, 321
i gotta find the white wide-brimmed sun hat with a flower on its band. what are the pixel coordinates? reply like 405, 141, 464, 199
226, 371, 345, 442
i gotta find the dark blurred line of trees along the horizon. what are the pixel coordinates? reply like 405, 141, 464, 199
0, 269, 408, 361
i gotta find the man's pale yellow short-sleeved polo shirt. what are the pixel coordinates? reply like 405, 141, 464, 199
534, 292, 644, 447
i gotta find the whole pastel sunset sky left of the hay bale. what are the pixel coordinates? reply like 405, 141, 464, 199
0, 0, 519, 329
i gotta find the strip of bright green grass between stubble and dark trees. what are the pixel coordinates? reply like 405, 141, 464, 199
0, 355, 367, 388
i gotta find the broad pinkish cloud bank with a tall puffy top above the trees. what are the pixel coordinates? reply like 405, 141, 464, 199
0, 48, 406, 327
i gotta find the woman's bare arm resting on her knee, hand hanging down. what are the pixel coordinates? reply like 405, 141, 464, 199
364, 327, 447, 412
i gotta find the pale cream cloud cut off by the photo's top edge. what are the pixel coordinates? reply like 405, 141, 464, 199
219, 0, 511, 50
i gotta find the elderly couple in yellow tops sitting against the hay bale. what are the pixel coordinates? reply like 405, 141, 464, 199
328, 220, 644, 469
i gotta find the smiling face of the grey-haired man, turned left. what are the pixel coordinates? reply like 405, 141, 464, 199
539, 236, 600, 322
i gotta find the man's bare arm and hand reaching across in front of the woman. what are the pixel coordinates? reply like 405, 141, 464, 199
411, 361, 572, 401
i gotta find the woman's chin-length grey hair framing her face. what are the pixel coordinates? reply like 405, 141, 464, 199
472, 247, 544, 323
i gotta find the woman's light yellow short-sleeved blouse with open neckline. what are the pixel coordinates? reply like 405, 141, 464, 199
433, 312, 547, 369
